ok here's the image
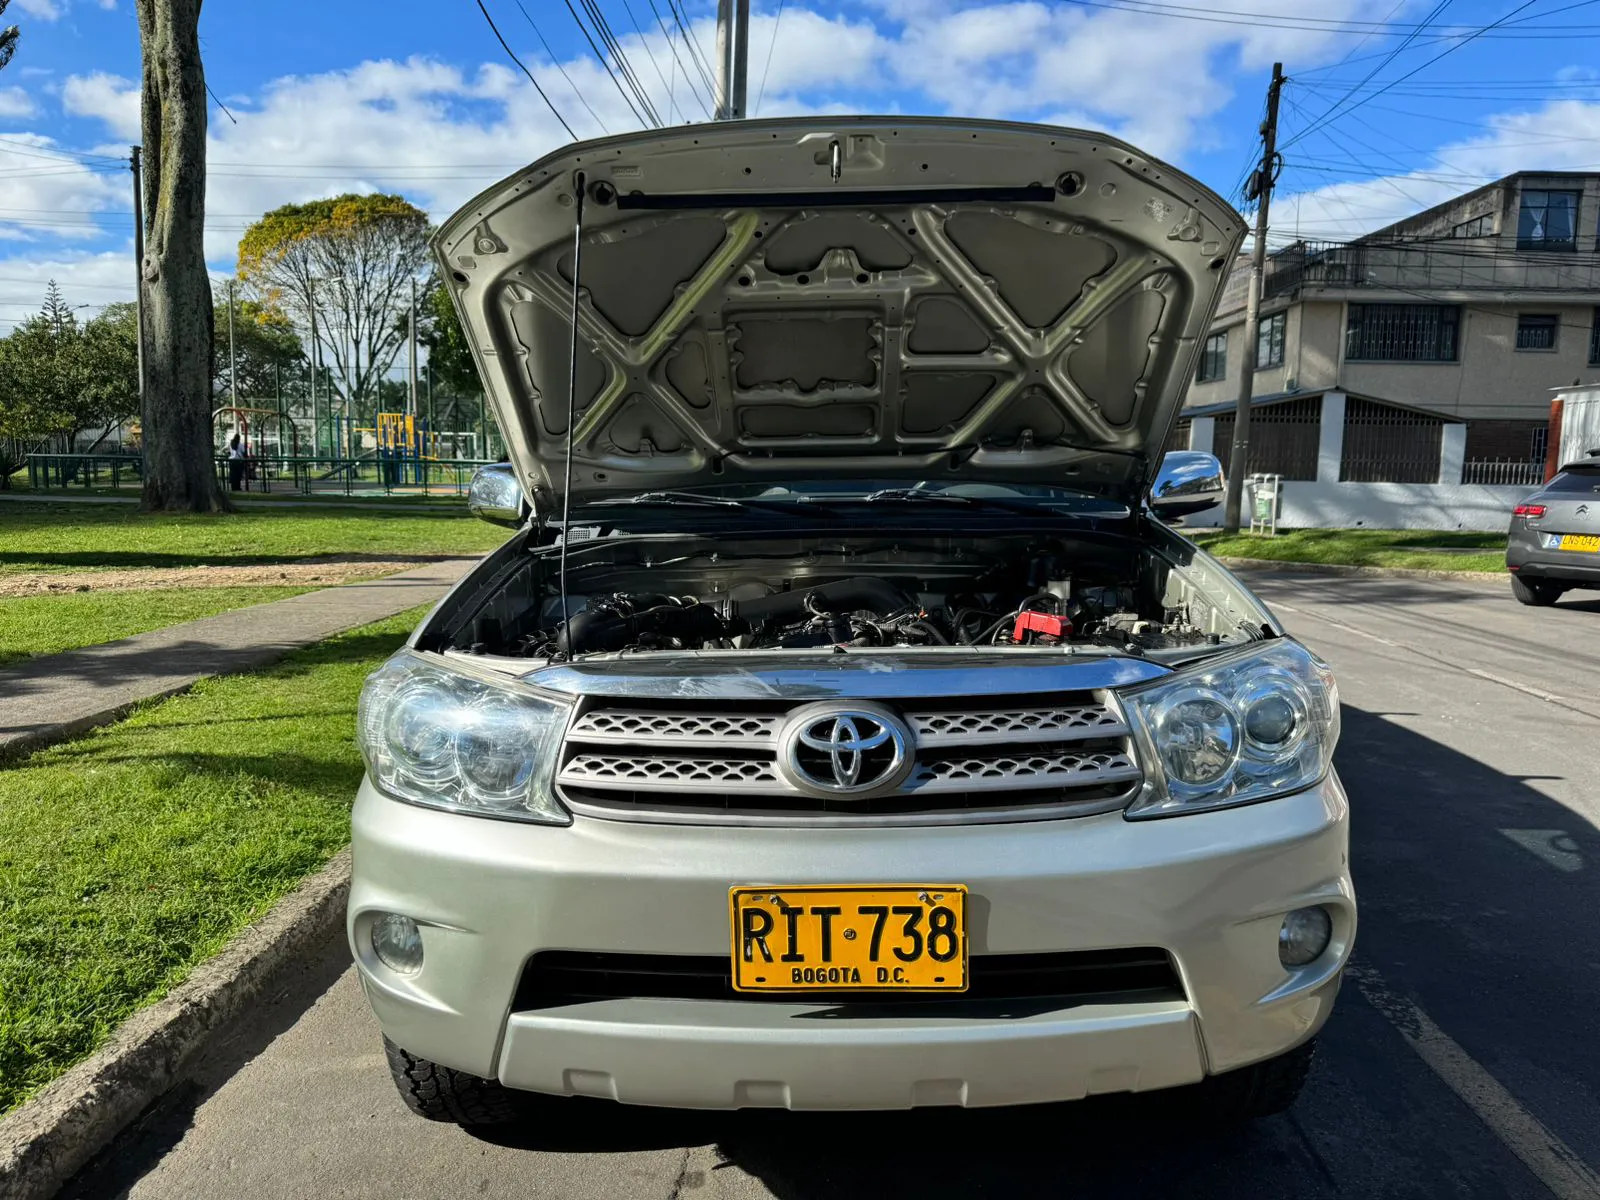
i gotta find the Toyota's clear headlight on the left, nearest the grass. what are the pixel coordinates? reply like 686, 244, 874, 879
357, 653, 571, 824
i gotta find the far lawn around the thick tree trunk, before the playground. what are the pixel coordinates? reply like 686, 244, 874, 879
0, 502, 510, 571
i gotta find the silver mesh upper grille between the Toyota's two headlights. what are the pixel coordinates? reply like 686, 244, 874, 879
557, 693, 1142, 824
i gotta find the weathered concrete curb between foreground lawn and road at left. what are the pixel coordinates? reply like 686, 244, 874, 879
0, 846, 350, 1200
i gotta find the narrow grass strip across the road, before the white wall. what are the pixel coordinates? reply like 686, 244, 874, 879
1189, 530, 1506, 571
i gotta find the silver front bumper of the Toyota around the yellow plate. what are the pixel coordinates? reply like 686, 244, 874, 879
349, 774, 1355, 1109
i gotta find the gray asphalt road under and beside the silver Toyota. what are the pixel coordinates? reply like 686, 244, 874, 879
66, 574, 1600, 1200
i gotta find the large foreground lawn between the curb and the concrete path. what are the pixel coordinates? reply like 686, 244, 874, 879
0, 608, 424, 1112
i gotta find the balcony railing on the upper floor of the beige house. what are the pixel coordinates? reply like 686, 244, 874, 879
1262, 238, 1600, 298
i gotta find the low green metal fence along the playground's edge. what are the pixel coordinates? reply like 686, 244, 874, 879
27, 454, 490, 496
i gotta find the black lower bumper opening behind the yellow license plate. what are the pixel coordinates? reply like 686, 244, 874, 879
515, 947, 1184, 1011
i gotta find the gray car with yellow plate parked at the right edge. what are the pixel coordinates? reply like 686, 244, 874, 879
1506, 458, 1600, 605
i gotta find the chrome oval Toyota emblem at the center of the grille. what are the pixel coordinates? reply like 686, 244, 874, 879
778, 704, 910, 797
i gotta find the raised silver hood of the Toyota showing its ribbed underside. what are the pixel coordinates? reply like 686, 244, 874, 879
434, 117, 1245, 512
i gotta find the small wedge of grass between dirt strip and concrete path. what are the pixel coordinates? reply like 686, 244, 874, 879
0, 587, 312, 667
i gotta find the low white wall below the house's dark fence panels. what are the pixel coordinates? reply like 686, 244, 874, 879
1184, 482, 1538, 533
